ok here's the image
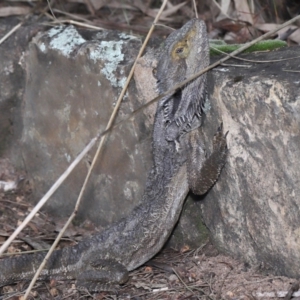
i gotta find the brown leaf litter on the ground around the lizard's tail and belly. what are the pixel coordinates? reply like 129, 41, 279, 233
0, 165, 297, 300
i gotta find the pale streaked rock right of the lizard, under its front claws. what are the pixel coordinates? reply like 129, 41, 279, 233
201, 47, 300, 277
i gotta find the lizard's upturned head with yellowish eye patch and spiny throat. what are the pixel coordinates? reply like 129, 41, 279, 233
156, 19, 209, 141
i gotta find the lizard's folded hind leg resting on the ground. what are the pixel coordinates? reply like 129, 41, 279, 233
76, 258, 128, 292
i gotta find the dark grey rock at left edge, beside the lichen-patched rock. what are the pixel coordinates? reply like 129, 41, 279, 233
0, 17, 44, 158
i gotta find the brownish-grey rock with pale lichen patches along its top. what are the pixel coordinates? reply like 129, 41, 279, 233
21, 26, 156, 225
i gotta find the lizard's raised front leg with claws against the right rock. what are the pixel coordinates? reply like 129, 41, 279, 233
187, 124, 228, 195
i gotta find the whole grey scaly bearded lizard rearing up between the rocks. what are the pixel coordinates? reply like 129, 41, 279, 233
0, 19, 227, 291
